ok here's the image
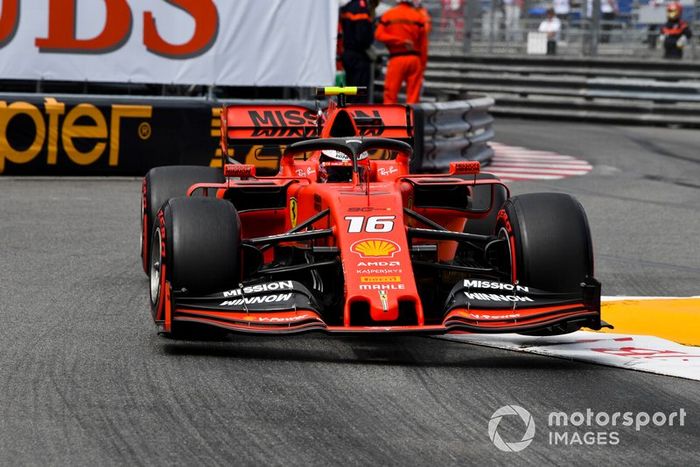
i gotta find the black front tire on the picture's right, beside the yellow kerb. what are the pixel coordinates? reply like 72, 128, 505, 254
497, 193, 593, 293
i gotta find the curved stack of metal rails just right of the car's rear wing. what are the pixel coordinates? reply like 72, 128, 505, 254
411, 97, 494, 172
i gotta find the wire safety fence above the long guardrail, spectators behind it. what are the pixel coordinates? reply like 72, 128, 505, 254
424, 0, 700, 60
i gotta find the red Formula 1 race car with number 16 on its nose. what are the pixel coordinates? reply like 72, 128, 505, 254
142, 89, 601, 335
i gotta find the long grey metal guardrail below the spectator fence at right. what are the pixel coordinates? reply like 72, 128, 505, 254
424, 55, 700, 127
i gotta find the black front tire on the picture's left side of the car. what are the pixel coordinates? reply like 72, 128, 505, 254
149, 197, 241, 332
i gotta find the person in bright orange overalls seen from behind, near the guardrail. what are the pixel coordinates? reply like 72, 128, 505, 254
375, 0, 428, 104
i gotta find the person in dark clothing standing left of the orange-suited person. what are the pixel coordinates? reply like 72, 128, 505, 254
340, 0, 379, 102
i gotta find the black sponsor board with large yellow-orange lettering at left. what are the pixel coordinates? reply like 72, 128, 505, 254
0, 94, 220, 176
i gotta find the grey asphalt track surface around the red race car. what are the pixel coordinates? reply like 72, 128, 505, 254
0, 121, 700, 465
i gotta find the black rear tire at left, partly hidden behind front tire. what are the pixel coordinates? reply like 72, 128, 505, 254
140, 165, 221, 274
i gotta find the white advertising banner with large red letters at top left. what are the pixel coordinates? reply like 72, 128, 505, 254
0, 0, 338, 86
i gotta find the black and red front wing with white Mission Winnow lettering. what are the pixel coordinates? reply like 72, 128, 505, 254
161, 279, 601, 334
